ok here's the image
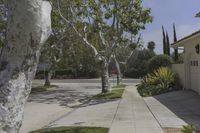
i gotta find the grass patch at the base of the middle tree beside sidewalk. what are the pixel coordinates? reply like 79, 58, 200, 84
92, 85, 126, 100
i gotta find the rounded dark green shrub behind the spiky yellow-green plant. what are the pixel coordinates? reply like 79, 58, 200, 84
148, 55, 173, 72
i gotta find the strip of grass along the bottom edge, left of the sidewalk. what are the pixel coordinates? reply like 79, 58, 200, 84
30, 127, 109, 133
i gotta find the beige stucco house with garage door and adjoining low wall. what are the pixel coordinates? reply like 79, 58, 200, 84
172, 31, 200, 94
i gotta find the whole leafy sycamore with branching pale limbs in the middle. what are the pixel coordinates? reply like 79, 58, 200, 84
57, 0, 152, 93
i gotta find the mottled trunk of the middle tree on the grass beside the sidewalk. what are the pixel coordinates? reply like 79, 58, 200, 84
101, 60, 111, 93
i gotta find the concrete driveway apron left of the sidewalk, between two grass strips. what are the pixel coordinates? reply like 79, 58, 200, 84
47, 100, 120, 128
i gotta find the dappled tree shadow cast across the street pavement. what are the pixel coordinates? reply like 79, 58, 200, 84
28, 84, 119, 108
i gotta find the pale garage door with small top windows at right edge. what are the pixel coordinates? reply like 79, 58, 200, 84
190, 60, 199, 92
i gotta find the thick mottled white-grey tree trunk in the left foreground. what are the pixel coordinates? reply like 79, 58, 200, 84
0, 0, 51, 133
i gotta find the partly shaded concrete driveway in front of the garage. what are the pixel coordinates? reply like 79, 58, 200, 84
144, 91, 200, 131
